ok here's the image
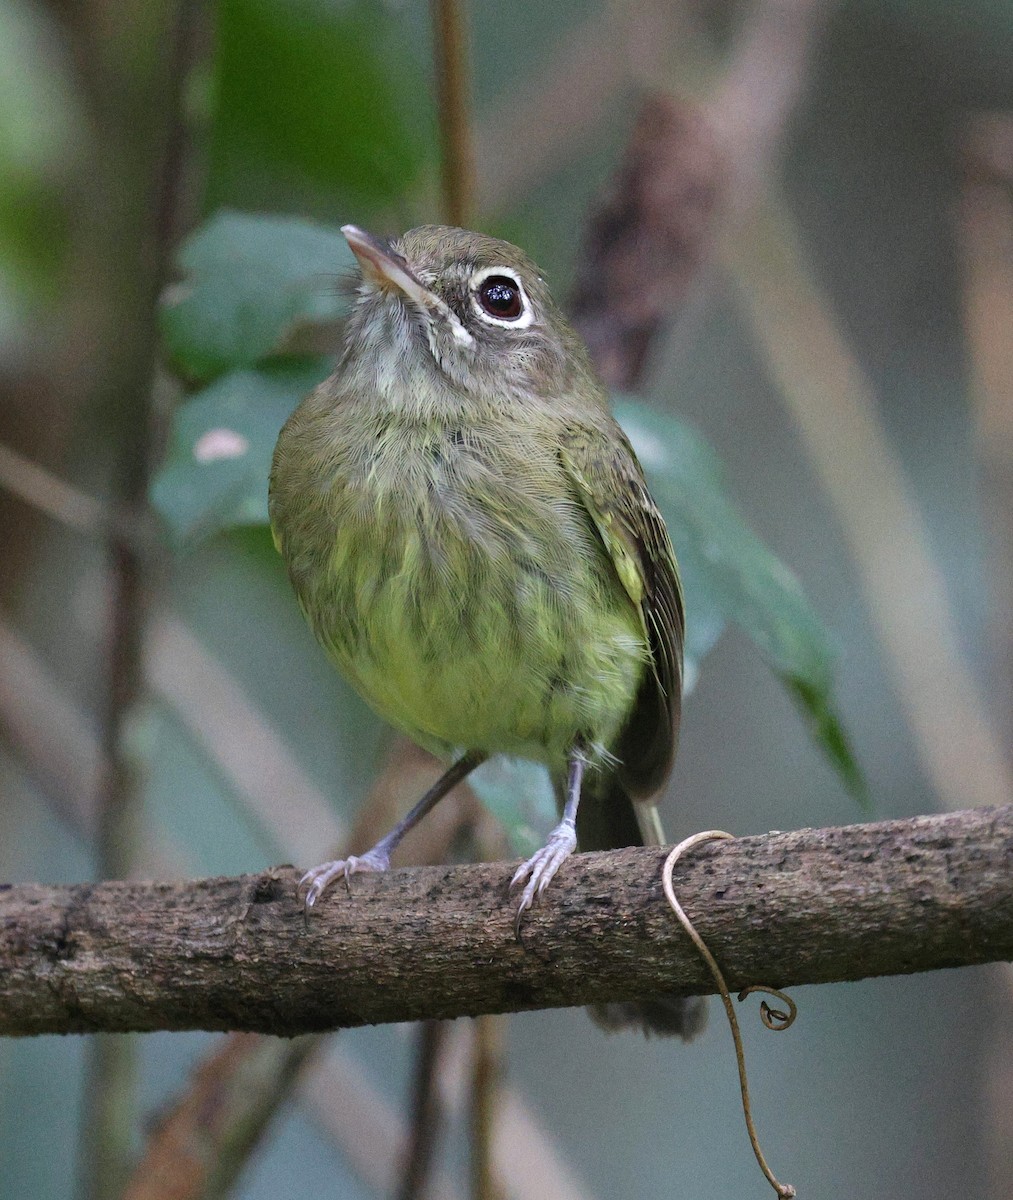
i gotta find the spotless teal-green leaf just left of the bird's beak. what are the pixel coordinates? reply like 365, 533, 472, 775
162, 212, 354, 379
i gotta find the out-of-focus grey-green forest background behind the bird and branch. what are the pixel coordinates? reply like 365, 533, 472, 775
0, 0, 1013, 1200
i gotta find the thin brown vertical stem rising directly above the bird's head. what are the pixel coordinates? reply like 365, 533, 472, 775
432, 0, 475, 227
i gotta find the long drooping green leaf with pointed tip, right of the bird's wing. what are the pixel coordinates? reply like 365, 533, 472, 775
616, 397, 870, 809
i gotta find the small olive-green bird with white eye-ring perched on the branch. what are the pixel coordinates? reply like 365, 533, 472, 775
270, 226, 701, 1037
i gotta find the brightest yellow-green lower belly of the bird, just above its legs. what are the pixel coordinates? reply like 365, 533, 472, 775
336, 538, 643, 762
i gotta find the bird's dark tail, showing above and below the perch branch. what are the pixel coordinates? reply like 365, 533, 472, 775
577, 772, 707, 1042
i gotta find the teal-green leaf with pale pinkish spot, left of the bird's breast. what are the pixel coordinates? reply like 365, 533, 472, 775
151, 359, 331, 544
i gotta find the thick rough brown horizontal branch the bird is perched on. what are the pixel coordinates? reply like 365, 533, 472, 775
0, 805, 1013, 1036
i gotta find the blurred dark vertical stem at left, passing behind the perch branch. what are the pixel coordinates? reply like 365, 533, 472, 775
82, 0, 205, 1200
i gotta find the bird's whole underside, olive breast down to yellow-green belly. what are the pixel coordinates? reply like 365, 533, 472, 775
271, 397, 648, 767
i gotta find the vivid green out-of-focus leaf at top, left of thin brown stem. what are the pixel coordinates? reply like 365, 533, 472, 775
210, 0, 436, 206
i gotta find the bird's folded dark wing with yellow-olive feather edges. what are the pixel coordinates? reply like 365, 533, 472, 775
561, 424, 685, 799
